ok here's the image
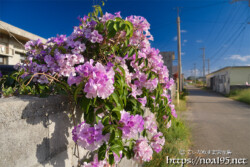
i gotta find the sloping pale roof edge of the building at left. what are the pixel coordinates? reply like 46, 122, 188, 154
0, 21, 47, 43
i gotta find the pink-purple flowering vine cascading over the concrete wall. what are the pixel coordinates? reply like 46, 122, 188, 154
16, 6, 177, 167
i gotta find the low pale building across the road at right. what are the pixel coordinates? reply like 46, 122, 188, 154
206, 66, 250, 94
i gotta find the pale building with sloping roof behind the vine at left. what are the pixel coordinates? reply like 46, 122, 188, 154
0, 21, 46, 65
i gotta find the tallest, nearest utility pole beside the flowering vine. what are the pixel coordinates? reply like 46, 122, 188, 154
177, 7, 182, 93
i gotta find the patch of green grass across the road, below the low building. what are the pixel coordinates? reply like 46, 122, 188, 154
229, 88, 250, 104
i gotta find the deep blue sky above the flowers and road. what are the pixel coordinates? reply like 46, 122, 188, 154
0, 0, 250, 77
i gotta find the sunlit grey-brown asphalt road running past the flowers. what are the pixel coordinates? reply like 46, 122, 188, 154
184, 86, 250, 167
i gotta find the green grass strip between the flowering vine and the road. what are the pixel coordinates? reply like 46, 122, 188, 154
143, 90, 190, 167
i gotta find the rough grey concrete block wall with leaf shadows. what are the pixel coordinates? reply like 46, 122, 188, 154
0, 96, 138, 167
